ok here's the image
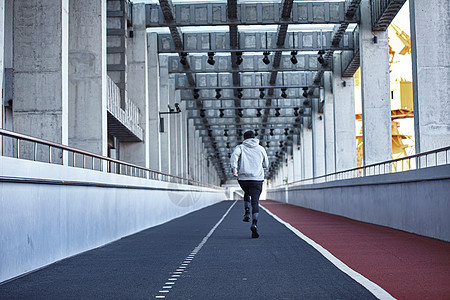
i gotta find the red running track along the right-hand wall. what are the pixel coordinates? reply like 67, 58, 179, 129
261, 200, 450, 300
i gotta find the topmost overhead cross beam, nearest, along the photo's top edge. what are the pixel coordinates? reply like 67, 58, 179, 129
145, 1, 358, 27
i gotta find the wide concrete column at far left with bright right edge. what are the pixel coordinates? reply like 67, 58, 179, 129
13, 0, 69, 154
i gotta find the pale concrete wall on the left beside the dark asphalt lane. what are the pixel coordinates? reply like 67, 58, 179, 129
0, 157, 226, 282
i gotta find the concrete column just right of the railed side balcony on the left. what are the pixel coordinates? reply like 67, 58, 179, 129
120, 0, 150, 168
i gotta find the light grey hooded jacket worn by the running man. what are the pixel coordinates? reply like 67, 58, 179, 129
230, 138, 269, 180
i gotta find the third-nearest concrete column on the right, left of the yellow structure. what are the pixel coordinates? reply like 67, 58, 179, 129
333, 53, 356, 172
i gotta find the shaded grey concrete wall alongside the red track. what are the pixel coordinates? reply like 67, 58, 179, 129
267, 165, 450, 241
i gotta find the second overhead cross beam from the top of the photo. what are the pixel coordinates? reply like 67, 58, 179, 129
158, 31, 354, 53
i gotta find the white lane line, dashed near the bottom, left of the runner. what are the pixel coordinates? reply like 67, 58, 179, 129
155, 201, 237, 299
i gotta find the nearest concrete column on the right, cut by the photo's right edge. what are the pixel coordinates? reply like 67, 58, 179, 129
409, 0, 450, 153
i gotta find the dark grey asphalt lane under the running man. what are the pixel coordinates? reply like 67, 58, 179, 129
0, 201, 375, 299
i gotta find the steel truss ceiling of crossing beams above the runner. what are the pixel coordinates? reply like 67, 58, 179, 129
146, 0, 405, 181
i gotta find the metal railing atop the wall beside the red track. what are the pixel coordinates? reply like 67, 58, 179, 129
274, 146, 450, 188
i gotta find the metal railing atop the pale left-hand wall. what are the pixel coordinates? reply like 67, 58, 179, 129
0, 129, 222, 189
